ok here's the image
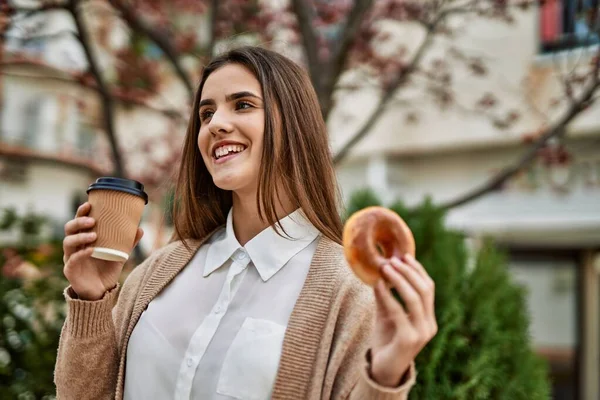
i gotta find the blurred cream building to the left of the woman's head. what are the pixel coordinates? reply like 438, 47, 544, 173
0, 2, 186, 251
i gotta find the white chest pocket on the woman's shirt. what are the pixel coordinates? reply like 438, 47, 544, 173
217, 318, 286, 400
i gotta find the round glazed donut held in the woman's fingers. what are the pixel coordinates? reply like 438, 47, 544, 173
343, 206, 415, 286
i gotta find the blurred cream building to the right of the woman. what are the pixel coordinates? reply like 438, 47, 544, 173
330, 1, 600, 400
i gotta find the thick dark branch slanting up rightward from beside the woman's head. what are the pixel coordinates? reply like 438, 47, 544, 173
321, 0, 373, 120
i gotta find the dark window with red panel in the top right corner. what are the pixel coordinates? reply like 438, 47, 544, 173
540, 0, 600, 53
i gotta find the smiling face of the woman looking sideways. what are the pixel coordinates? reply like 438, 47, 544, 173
198, 64, 265, 194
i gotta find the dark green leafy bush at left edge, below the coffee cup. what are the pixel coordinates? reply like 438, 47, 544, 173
0, 209, 67, 400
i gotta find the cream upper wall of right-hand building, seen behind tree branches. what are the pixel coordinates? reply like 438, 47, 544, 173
328, 8, 600, 158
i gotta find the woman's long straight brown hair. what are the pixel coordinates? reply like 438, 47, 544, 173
173, 47, 342, 243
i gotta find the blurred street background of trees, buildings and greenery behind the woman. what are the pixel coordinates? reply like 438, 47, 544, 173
0, 0, 600, 400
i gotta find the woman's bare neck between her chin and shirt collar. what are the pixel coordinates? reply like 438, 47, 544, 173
232, 188, 295, 246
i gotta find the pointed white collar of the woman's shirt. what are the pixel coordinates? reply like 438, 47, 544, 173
204, 209, 319, 282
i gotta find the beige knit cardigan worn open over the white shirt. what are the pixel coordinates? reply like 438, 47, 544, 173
54, 236, 416, 400
